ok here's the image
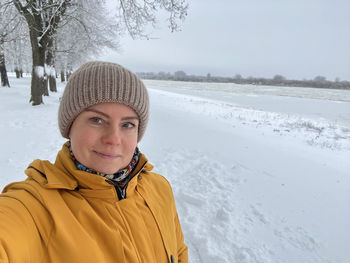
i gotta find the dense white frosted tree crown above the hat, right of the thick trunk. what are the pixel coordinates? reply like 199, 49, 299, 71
54, 0, 123, 81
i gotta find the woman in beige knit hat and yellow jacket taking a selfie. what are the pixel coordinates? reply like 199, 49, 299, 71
0, 62, 188, 263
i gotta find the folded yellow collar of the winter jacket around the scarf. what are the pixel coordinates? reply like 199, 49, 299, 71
25, 142, 153, 190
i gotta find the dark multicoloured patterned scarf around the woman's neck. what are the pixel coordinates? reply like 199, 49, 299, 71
69, 146, 140, 199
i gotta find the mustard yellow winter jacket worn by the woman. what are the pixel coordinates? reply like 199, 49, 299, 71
0, 143, 188, 263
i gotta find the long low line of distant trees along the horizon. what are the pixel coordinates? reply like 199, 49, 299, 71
137, 70, 350, 90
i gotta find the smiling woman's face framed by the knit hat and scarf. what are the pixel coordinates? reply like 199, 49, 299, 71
69, 102, 139, 174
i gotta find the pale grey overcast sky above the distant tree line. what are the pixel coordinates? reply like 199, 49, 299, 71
101, 0, 350, 80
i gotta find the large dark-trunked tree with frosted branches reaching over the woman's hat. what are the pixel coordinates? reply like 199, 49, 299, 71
8, 0, 188, 105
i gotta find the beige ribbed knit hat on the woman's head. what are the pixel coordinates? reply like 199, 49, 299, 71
58, 61, 149, 141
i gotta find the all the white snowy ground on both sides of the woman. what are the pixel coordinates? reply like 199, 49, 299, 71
0, 77, 350, 263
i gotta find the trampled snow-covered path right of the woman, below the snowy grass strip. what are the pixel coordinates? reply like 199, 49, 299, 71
142, 87, 350, 263
